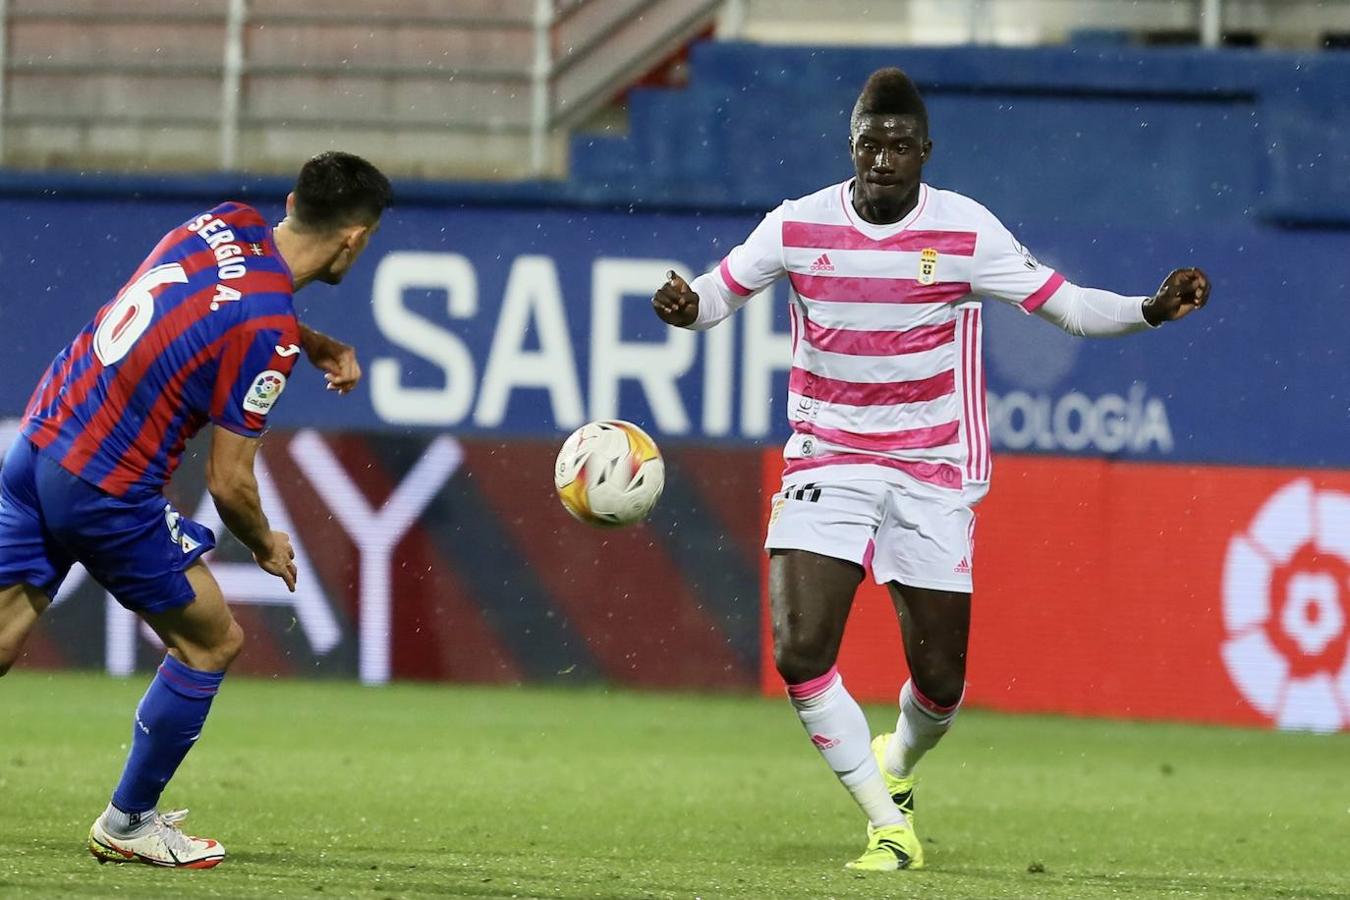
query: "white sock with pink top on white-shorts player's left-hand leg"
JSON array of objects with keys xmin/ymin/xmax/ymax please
[{"xmin": 787, "ymin": 668, "xmax": 905, "ymax": 828}]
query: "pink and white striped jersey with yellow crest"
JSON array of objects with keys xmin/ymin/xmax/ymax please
[{"xmin": 693, "ymin": 179, "xmax": 1072, "ymax": 488}]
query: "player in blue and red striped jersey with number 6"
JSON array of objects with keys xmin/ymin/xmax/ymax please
[{"xmin": 0, "ymin": 152, "xmax": 390, "ymax": 869}]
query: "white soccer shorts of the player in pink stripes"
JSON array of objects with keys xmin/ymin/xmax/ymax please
[{"xmin": 764, "ymin": 474, "xmax": 987, "ymax": 594}]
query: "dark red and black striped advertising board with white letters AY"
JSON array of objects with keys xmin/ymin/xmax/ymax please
[{"xmin": 10, "ymin": 430, "xmax": 761, "ymax": 688}]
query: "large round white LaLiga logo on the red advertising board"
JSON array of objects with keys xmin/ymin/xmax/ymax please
[{"xmin": 1222, "ymin": 479, "xmax": 1350, "ymax": 731}]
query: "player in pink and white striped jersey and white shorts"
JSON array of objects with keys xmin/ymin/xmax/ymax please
[{"xmin": 652, "ymin": 69, "xmax": 1210, "ymax": 870}]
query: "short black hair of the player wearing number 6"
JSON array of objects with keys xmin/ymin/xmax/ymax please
[{"xmin": 288, "ymin": 150, "xmax": 394, "ymax": 231}]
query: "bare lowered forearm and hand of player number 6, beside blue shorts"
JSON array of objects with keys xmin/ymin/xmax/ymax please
[{"xmin": 207, "ymin": 425, "xmax": 297, "ymax": 591}]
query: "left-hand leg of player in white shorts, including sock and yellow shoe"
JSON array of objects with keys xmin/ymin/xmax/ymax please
[{"xmin": 770, "ymin": 551, "xmax": 923, "ymax": 870}]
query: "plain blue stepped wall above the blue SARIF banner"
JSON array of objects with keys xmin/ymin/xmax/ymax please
[{"xmin": 574, "ymin": 43, "xmax": 1350, "ymax": 224}]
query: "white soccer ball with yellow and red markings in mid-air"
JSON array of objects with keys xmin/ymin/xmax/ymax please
[{"xmin": 554, "ymin": 420, "xmax": 666, "ymax": 526}]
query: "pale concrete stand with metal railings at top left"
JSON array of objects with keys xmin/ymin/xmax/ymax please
[{"xmin": 0, "ymin": 0, "xmax": 718, "ymax": 178}]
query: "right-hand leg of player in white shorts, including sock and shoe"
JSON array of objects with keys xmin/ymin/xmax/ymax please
[{"xmin": 873, "ymin": 583, "xmax": 971, "ymax": 823}]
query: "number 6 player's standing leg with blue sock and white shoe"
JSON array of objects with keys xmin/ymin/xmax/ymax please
[{"xmin": 89, "ymin": 561, "xmax": 243, "ymax": 869}]
